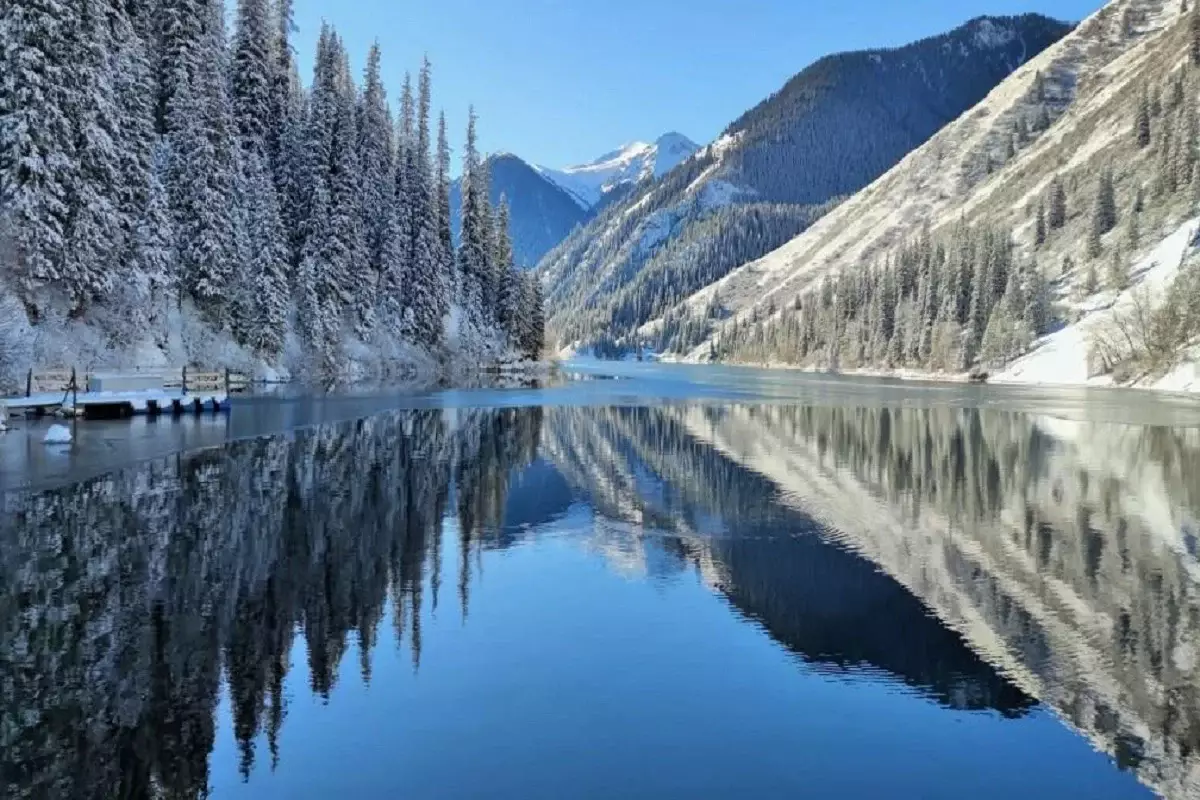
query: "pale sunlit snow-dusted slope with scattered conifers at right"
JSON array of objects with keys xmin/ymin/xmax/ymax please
[{"xmin": 662, "ymin": 0, "xmax": 1200, "ymax": 389}]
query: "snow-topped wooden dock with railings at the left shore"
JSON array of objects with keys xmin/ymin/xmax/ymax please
[{"xmin": 0, "ymin": 367, "xmax": 250, "ymax": 419}]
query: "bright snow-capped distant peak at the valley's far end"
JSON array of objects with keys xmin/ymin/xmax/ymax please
[{"xmin": 536, "ymin": 132, "xmax": 700, "ymax": 210}]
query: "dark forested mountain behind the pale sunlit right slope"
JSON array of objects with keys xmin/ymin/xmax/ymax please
[{"xmin": 540, "ymin": 14, "xmax": 1069, "ymax": 357}]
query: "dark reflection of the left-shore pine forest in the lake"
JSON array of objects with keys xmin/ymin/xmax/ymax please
[{"xmin": 0, "ymin": 410, "xmax": 549, "ymax": 796}]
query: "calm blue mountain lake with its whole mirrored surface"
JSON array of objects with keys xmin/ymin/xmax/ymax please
[{"xmin": 0, "ymin": 365, "xmax": 1200, "ymax": 800}]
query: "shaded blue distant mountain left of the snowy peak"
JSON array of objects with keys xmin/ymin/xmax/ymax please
[{"xmin": 450, "ymin": 152, "xmax": 588, "ymax": 267}]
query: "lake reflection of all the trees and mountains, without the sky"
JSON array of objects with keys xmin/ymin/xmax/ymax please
[{"xmin": 0, "ymin": 405, "xmax": 1200, "ymax": 798}]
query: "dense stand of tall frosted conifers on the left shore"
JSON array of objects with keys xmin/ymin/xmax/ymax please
[{"xmin": 0, "ymin": 0, "xmax": 540, "ymax": 388}]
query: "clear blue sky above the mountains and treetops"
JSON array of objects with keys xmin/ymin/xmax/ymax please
[{"xmin": 288, "ymin": 0, "xmax": 1100, "ymax": 167}]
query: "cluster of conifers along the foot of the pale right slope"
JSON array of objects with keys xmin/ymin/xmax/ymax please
[{"xmin": 710, "ymin": 223, "xmax": 1051, "ymax": 372}]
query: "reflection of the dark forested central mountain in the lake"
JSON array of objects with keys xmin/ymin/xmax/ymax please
[{"xmin": 542, "ymin": 409, "xmax": 1031, "ymax": 715}]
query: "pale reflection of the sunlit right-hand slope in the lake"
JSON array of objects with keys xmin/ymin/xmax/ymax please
[{"xmin": 677, "ymin": 408, "xmax": 1200, "ymax": 798}]
